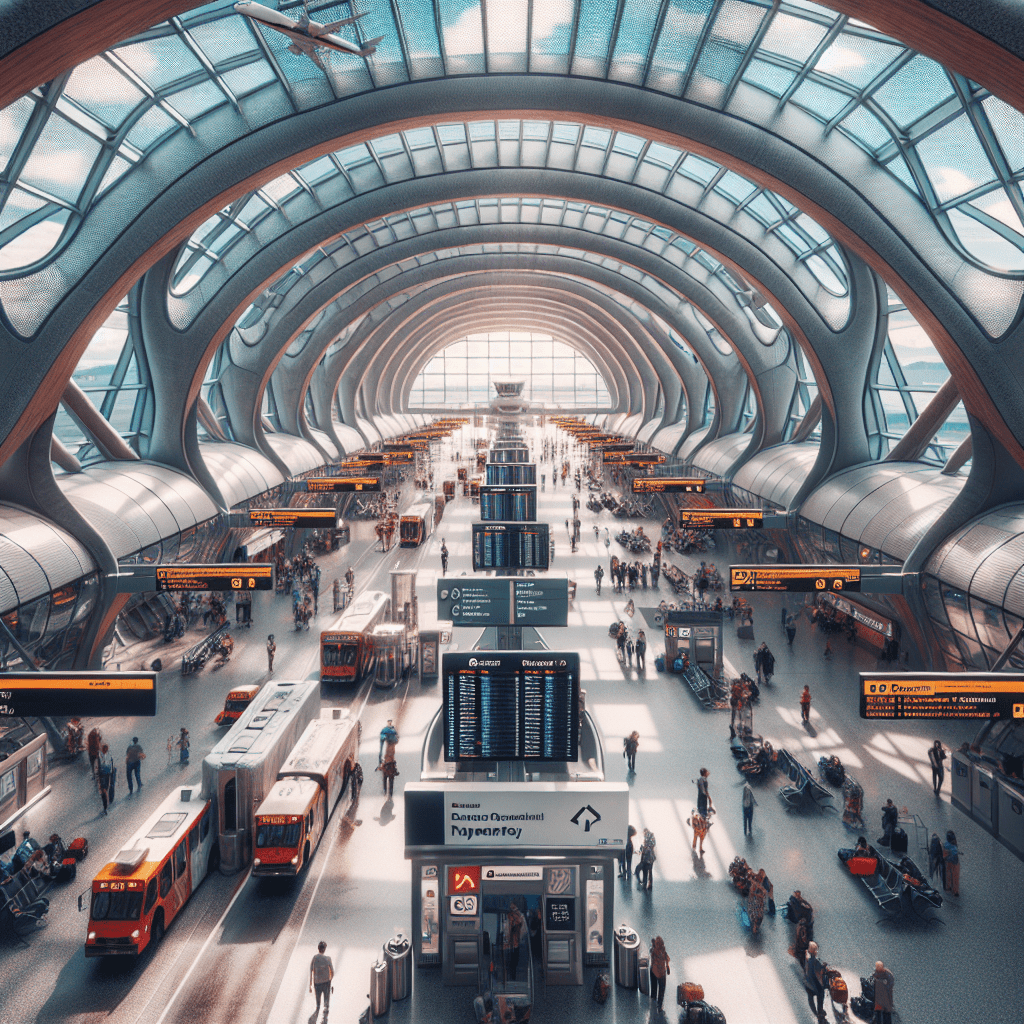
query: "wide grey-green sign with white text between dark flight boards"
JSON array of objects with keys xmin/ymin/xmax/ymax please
[{"xmin": 437, "ymin": 577, "xmax": 569, "ymax": 626}]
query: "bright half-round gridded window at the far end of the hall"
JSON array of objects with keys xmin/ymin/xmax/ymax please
[{"xmin": 410, "ymin": 331, "xmax": 611, "ymax": 410}]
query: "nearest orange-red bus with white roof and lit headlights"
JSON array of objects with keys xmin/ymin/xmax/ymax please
[{"xmin": 85, "ymin": 784, "xmax": 217, "ymax": 956}]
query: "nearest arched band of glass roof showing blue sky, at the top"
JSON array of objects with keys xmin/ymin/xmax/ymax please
[{"xmin": 0, "ymin": 0, "xmax": 1024, "ymax": 284}]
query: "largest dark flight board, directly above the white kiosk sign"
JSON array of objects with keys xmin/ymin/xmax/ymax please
[{"xmin": 441, "ymin": 651, "xmax": 580, "ymax": 761}]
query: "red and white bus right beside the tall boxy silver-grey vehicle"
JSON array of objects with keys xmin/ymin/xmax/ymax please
[{"xmin": 253, "ymin": 708, "xmax": 361, "ymax": 877}]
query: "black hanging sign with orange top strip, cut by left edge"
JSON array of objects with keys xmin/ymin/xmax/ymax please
[{"xmin": 0, "ymin": 672, "xmax": 157, "ymax": 718}]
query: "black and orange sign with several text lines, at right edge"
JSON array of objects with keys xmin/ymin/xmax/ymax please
[{"xmin": 860, "ymin": 672, "xmax": 1024, "ymax": 722}]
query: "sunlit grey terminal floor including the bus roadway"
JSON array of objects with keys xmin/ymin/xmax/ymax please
[{"xmin": 0, "ymin": 432, "xmax": 1024, "ymax": 1024}]
